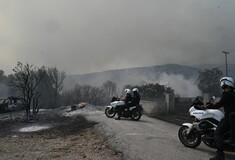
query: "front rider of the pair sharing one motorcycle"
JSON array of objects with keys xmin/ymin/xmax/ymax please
[{"xmin": 116, "ymin": 89, "xmax": 132, "ymax": 120}]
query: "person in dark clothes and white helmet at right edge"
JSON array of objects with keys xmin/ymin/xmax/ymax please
[{"xmin": 206, "ymin": 77, "xmax": 235, "ymax": 160}]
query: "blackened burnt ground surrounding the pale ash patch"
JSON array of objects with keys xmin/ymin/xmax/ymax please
[{"xmin": 0, "ymin": 113, "xmax": 97, "ymax": 138}]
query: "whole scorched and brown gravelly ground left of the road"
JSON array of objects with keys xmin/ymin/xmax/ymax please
[{"xmin": 0, "ymin": 109, "xmax": 123, "ymax": 160}]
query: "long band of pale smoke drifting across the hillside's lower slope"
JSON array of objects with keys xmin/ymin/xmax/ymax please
[{"xmin": 65, "ymin": 66, "xmax": 202, "ymax": 97}]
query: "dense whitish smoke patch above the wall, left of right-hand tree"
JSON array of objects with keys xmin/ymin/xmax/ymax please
[{"xmin": 158, "ymin": 73, "xmax": 202, "ymax": 97}]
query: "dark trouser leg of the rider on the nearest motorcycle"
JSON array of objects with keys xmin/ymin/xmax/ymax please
[{"xmin": 215, "ymin": 118, "xmax": 230, "ymax": 152}]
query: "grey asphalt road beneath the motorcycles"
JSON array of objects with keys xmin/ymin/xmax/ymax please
[{"xmin": 75, "ymin": 106, "xmax": 235, "ymax": 160}]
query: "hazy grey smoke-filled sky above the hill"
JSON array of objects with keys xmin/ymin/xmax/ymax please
[{"xmin": 0, "ymin": 0, "xmax": 235, "ymax": 74}]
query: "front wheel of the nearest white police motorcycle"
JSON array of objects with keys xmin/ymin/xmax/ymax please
[{"xmin": 178, "ymin": 126, "xmax": 201, "ymax": 148}]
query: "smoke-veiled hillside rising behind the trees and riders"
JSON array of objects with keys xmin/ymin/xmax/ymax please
[{"xmin": 65, "ymin": 64, "xmax": 202, "ymax": 96}]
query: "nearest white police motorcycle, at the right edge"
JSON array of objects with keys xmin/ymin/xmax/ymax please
[{"xmin": 178, "ymin": 97, "xmax": 235, "ymax": 152}]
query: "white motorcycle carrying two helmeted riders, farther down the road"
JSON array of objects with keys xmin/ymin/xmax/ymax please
[{"xmin": 105, "ymin": 97, "xmax": 143, "ymax": 121}]
